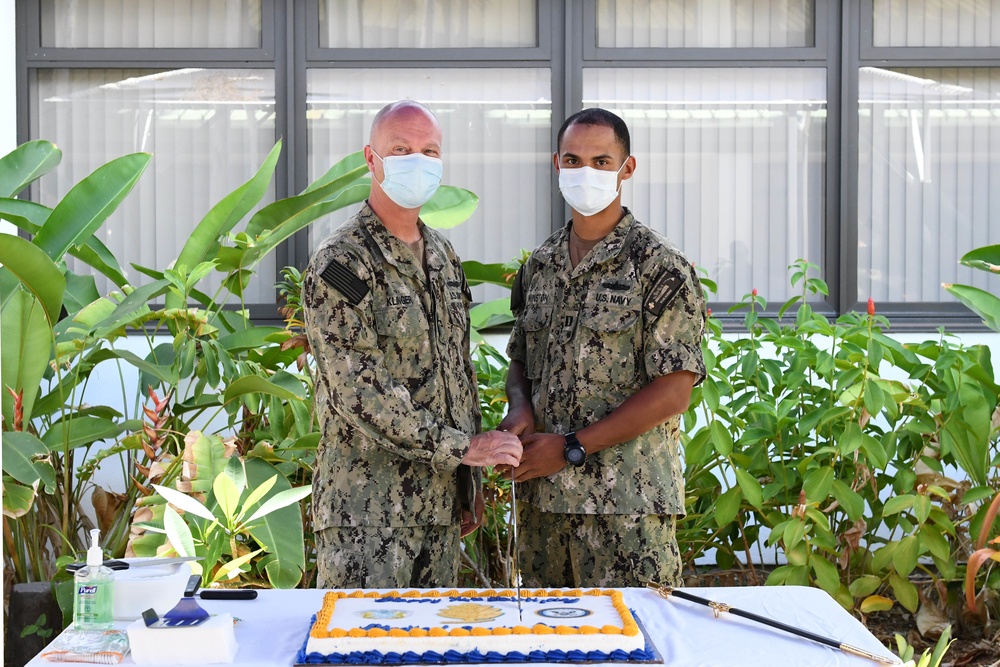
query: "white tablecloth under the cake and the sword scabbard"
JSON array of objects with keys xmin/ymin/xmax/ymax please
[{"xmin": 28, "ymin": 586, "xmax": 892, "ymax": 667}]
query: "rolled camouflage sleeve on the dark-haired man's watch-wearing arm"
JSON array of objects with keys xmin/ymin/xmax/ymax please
[{"xmin": 643, "ymin": 262, "xmax": 706, "ymax": 384}]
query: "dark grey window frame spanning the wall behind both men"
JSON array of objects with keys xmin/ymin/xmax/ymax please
[{"xmin": 15, "ymin": 0, "xmax": 1000, "ymax": 331}]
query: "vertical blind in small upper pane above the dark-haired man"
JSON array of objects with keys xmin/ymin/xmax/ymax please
[{"xmin": 597, "ymin": 0, "xmax": 816, "ymax": 48}]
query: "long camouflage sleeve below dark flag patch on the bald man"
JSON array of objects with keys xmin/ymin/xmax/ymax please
[{"xmin": 302, "ymin": 257, "xmax": 470, "ymax": 472}]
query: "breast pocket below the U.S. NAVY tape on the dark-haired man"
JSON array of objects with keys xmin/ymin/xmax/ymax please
[{"xmin": 577, "ymin": 305, "xmax": 640, "ymax": 386}]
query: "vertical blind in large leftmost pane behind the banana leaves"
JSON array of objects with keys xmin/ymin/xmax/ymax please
[{"xmin": 31, "ymin": 68, "xmax": 275, "ymax": 303}]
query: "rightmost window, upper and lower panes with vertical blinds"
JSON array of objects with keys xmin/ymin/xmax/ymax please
[{"xmin": 856, "ymin": 0, "xmax": 1000, "ymax": 319}]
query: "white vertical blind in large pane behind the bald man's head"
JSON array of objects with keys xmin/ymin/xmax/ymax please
[{"xmin": 307, "ymin": 68, "xmax": 552, "ymax": 298}]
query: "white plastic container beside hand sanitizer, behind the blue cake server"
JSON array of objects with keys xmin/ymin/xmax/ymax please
[{"xmin": 112, "ymin": 558, "xmax": 191, "ymax": 621}]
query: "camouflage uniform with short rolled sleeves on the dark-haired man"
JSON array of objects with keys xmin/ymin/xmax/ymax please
[{"xmin": 507, "ymin": 209, "xmax": 705, "ymax": 586}]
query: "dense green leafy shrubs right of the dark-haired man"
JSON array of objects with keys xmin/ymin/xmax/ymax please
[{"xmin": 678, "ymin": 262, "xmax": 1000, "ymax": 632}]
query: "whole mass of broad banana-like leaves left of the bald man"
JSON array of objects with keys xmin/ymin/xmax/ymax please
[{"xmin": 0, "ymin": 141, "xmax": 478, "ymax": 585}]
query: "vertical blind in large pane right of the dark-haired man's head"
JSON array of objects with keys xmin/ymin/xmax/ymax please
[{"xmin": 583, "ymin": 68, "xmax": 826, "ymax": 301}]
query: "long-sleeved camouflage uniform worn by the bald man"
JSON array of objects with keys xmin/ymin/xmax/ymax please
[{"xmin": 303, "ymin": 203, "xmax": 480, "ymax": 588}]
